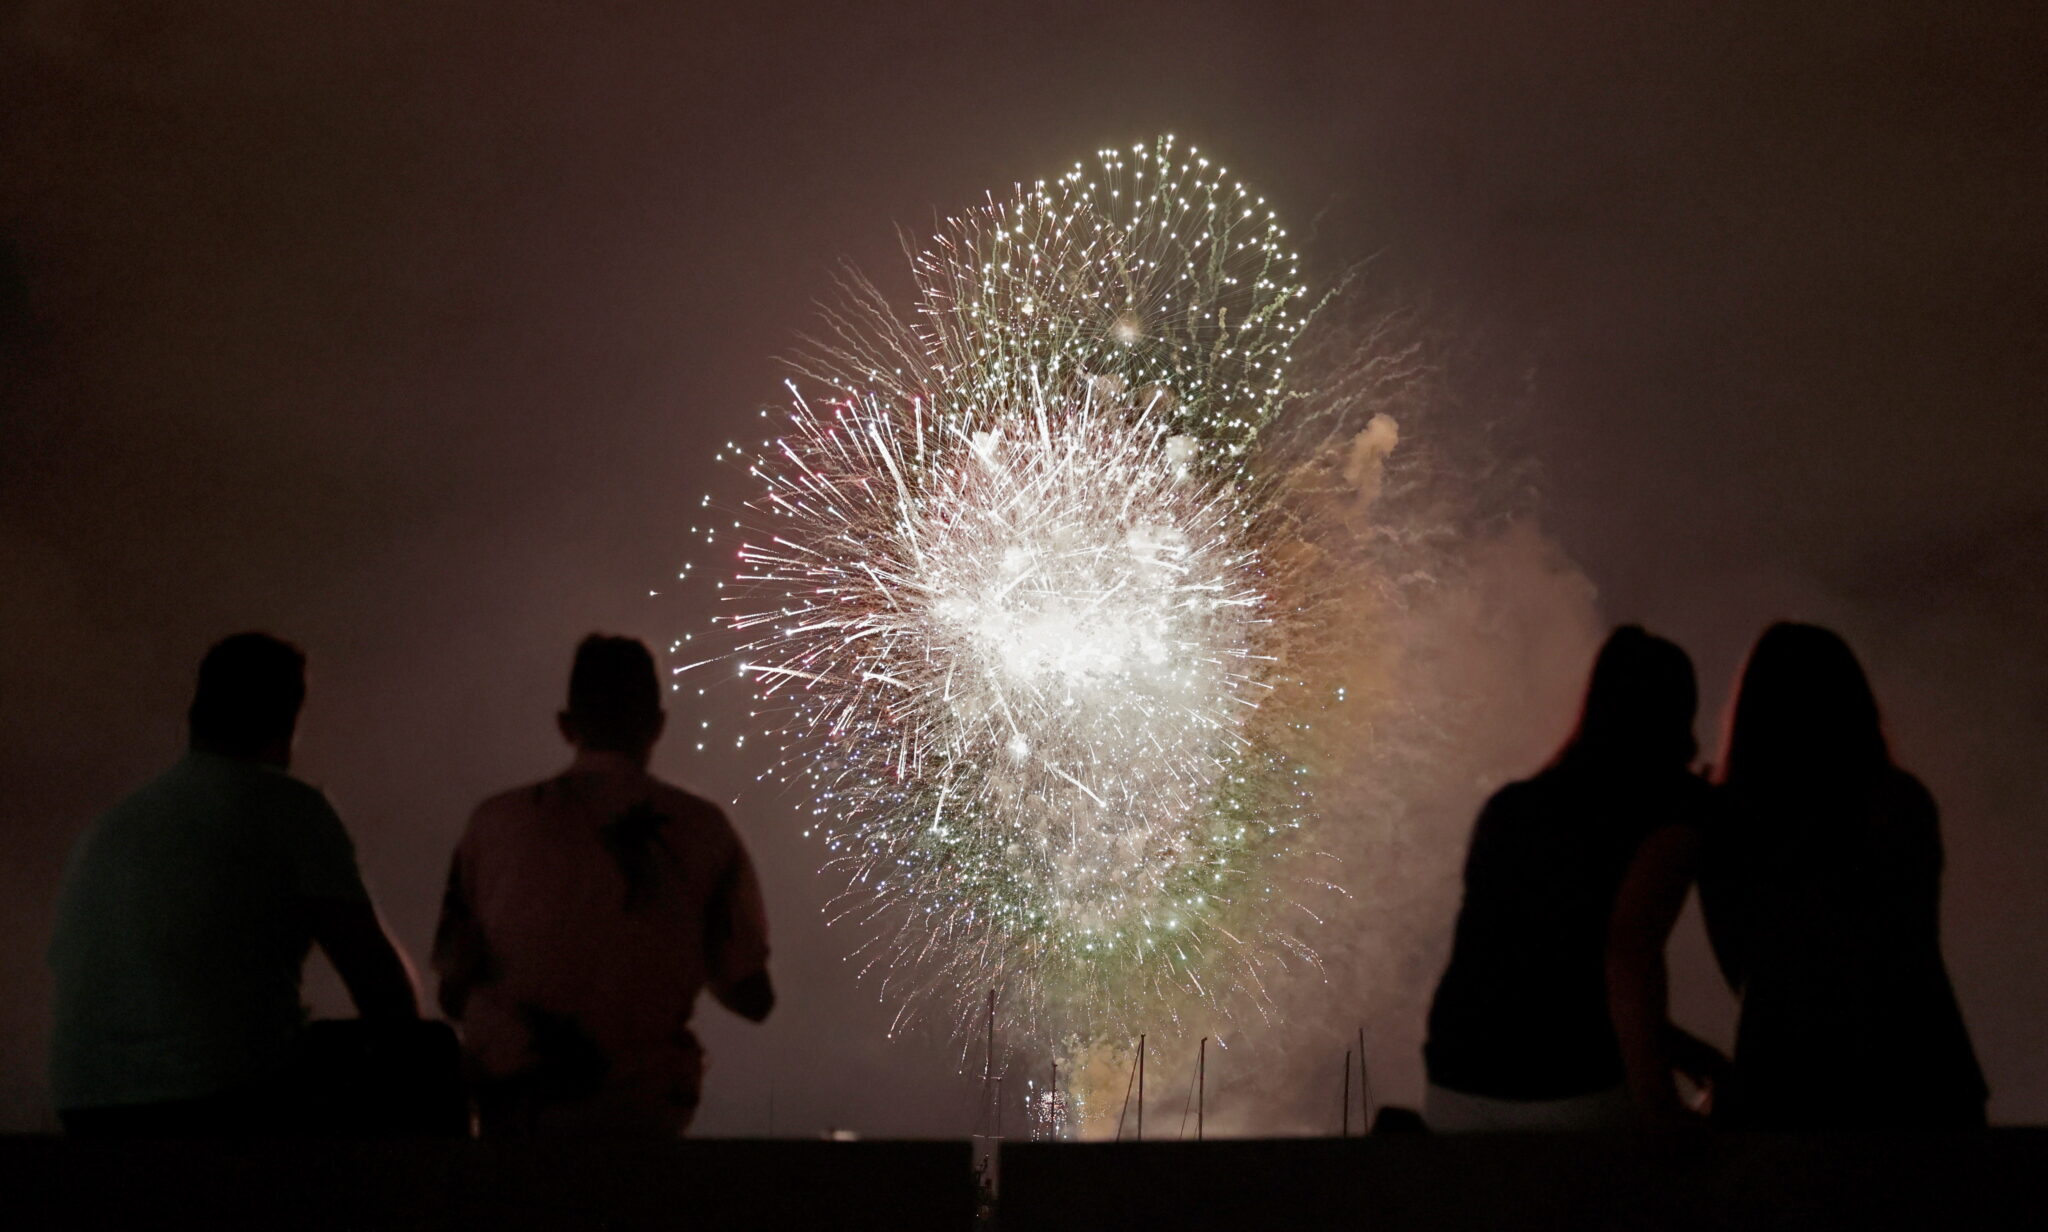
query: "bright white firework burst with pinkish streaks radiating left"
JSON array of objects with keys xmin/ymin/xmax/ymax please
[{"xmin": 741, "ymin": 385, "xmax": 1262, "ymax": 948}]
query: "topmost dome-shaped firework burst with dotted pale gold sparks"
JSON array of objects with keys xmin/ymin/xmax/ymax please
[{"xmin": 799, "ymin": 137, "xmax": 1309, "ymax": 463}]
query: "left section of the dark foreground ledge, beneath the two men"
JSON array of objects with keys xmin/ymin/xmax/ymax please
[{"xmin": 0, "ymin": 1136, "xmax": 975, "ymax": 1232}]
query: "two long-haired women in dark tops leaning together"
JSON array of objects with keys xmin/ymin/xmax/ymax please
[{"xmin": 1423, "ymin": 624, "xmax": 1987, "ymax": 1130}]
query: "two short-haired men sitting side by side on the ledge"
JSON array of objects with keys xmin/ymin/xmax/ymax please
[{"xmin": 49, "ymin": 634, "xmax": 774, "ymax": 1136}]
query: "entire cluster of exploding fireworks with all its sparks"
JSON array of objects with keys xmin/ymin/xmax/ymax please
[{"xmin": 678, "ymin": 139, "xmax": 1395, "ymax": 1046}]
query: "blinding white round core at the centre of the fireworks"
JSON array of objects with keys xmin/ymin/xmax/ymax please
[{"xmin": 905, "ymin": 407, "xmax": 1260, "ymax": 829}]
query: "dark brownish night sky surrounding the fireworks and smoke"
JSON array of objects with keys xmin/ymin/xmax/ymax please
[{"xmin": 0, "ymin": 0, "xmax": 2048, "ymax": 1134}]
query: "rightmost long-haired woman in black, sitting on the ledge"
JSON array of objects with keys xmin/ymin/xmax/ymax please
[{"xmin": 1700, "ymin": 624, "xmax": 1987, "ymax": 1130}]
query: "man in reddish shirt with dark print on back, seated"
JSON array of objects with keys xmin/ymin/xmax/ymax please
[{"xmin": 434, "ymin": 634, "xmax": 774, "ymax": 1138}]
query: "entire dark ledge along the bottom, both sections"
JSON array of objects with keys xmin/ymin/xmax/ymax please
[{"xmin": 0, "ymin": 1130, "xmax": 2048, "ymax": 1232}]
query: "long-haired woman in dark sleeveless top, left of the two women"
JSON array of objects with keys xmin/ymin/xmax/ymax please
[{"xmin": 1423, "ymin": 626, "xmax": 1712, "ymax": 1130}]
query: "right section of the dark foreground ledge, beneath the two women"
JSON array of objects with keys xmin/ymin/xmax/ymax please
[{"xmin": 1001, "ymin": 1130, "xmax": 2048, "ymax": 1232}]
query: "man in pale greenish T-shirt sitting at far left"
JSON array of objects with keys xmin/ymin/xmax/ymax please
[{"xmin": 49, "ymin": 632, "xmax": 418, "ymax": 1136}]
